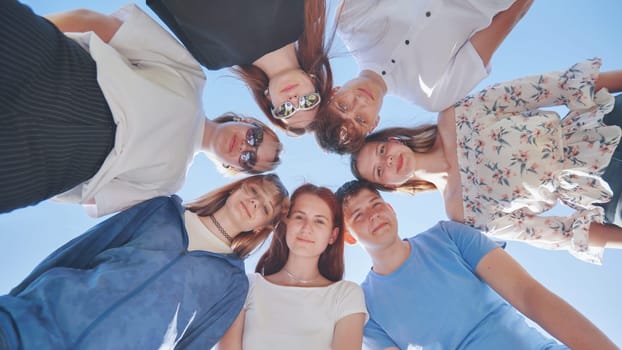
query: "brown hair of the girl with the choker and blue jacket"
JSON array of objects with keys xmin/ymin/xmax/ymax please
[{"xmin": 185, "ymin": 174, "xmax": 289, "ymax": 258}]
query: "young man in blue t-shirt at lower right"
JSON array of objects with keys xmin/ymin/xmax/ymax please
[{"xmin": 337, "ymin": 181, "xmax": 617, "ymax": 350}]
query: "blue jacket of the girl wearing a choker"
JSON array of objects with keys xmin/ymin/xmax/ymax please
[{"xmin": 0, "ymin": 196, "xmax": 248, "ymax": 350}]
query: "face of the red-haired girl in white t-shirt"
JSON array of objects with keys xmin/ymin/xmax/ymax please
[{"xmin": 285, "ymin": 193, "xmax": 339, "ymax": 257}]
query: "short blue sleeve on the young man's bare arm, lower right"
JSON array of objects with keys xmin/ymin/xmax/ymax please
[{"xmin": 440, "ymin": 221, "xmax": 505, "ymax": 271}]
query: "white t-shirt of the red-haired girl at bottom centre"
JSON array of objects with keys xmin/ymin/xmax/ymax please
[{"xmin": 243, "ymin": 273, "xmax": 367, "ymax": 350}]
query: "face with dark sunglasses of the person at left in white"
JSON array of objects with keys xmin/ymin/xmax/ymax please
[{"xmin": 213, "ymin": 122, "xmax": 279, "ymax": 172}]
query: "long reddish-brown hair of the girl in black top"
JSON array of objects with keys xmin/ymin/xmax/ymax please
[{"xmin": 232, "ymin": 0, "xmax": 335, "ymax": 135}]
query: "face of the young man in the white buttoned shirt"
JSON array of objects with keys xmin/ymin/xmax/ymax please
[{"xmin": 328, "ymin": 77, "xmax": 384, "ymax": 135}]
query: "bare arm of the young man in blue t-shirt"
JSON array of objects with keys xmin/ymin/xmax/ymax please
[{"xmin": 475, "ymin": 248, "xmax": 617, "ymax": 349}]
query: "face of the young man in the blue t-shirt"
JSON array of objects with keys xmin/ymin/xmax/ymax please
[{"xmin": 343, "ymin": 189, "xmax": 399, "ymax": 250}]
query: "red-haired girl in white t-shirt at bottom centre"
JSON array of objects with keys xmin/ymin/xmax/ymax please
[{"xmin": 218, "ymin": 184, "xmax": 367, "ymax": 350}]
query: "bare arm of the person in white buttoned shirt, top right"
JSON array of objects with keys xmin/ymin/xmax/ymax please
[{"xmin": 471, "ymin": 0, "xmax": 533, "ymax": 66}]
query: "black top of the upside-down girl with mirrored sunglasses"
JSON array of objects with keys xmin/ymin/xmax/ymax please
[{"xmin": 147, "ymin": 0, "xmax": 304, "ymax": 69}]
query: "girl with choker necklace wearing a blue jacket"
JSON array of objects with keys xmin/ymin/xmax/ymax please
[{"xmin": 0, "ymin": 174, "xmax": 289, "ymax": 349}]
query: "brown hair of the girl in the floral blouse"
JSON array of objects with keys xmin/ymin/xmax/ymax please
[{"xmin": 350, "ymin": 124, "xmax": 437, "ymax": 195}]
